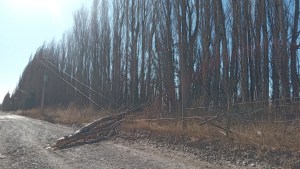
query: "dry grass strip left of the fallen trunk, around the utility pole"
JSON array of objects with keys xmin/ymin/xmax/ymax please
[{"xmin": 19, "ymin": 104, "xmax": 109, "ymax": 124}]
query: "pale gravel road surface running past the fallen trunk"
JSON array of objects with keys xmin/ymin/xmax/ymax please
[{"xmin": 0, "ymin": 112, "xmax": 258, "ymax": 169}]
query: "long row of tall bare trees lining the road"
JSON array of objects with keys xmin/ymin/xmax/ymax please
[{"xmin": 4, "ymin": 0, "xmax": 299, "ymax": 115}]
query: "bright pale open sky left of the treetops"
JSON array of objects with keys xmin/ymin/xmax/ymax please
[{"xmin": 0, "ymin": 0, "xmax": 92, "ymax": 103}]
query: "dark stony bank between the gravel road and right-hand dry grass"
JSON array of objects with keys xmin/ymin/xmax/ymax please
[{"xmin": 117, "ymin": 129, "xmax": 300, "ymax": 169}]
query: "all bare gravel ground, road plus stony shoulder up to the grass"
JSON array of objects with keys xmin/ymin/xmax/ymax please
[{"xmin": 0, "ymin": 112, "xmax": 300, "ymax": 169}]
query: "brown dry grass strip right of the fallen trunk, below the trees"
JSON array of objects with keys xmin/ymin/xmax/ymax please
[{"xmin": 123, "ymin": 119, "xmax": 300, "ymax": 153}]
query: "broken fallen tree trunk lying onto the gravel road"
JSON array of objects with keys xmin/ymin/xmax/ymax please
[{"xmin": 53, "ymin": 113, "xmax": 127, "ymax": 149}]
